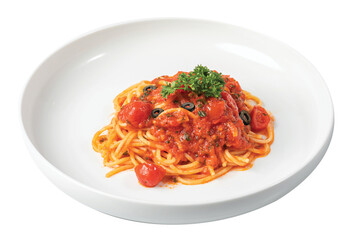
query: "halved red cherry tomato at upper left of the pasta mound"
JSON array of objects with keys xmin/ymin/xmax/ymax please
[{"xmin": 118, "ymin": 101, "xmax": 152, "ymax": 128}]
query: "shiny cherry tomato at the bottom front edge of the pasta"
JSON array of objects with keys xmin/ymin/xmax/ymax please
[{"xmin": 135, "ymin": 163, "xmax": 166, "ymax": 187}]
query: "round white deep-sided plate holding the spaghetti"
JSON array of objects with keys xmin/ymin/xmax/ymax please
[{"xmin": 21, "ymin": 19, "xmax": 333, "ymax": 223}]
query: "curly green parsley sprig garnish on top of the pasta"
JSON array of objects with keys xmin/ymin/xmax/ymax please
[{"xmin": 161, "ymin": 65, "xmax": 225, "ymax": 98}]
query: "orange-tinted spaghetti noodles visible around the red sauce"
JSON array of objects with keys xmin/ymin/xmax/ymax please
[{"xmin": 92, "ymin": 67, "xmax": 274, "ymax": 185}]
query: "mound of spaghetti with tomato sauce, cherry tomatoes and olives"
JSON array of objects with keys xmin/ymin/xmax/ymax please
[{"xmin": 92, "ymin": 66, "xmax": 274, "ymax": 186}]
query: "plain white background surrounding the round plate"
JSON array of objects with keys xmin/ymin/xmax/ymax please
[{"xmin": 0, "ymin": 0, "xmax": 350, "ymax": 239}]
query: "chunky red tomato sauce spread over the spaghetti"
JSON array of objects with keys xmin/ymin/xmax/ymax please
[{"xmin": 119, "ymin": 72, "xmax": 252, "ymax": 168}]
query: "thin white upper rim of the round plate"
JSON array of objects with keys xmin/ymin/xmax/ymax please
[{"xmin": 19, "ymin": 17, "xmax": 334, "ymax": 206}]
